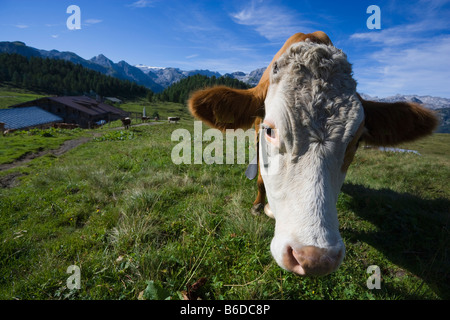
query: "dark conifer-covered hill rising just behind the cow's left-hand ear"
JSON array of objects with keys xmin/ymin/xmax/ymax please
[{"xmin": 156, "ymin": 74, "xmax": 250, "ymax": 103}]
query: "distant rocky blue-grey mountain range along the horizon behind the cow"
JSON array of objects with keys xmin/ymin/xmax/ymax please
[{"xmin": 0, "ymin": 41, "xmax": 450, "ymax": 110}]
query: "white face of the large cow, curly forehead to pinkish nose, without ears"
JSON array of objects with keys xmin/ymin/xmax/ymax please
[{"xmin": 259, "ymin": 41, "xmax": 364, "ymax": 275}]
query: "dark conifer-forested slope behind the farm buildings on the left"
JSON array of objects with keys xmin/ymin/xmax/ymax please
[{"xmin": 0, "ymin": 54, "xmax": 150, "ymax": 98}]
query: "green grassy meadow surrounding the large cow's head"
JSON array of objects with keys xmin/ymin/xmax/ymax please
[{"xmin": 0, "ymin": 93, "xmax": 450, "ymax": 300}]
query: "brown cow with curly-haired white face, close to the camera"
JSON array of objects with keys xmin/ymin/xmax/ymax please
[{"xmin": 189, "ymin": 31, "xmax": 438, "ymax": 276}]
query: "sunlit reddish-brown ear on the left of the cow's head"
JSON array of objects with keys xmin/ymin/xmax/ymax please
[{"xmin": 189, "ymin": 86, "xmax": 264, "ymax": 130}]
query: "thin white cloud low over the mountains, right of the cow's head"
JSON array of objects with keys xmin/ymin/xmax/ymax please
[{"xmin": 353, "ymin": 36, "xmax": 450, "ymax": 97}]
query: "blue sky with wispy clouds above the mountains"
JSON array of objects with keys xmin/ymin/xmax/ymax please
[{"xmin": 0, "ymin": 0, "xmax": 450, "ymax": 98}]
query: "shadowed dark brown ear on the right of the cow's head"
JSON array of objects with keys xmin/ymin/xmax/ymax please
[{"xmin": 359, "ymin": 97, "xmax": 439, "ymax": 146}]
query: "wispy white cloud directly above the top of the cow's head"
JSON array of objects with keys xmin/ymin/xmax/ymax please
[{"xmin": 231, "ymin": 1, "xmax": 310, "ymax": 41}]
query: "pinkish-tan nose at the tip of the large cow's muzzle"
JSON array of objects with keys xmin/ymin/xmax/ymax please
[{"xmin": 283, "ymin": 246, "xmax": 343, "ymax": 276}]
